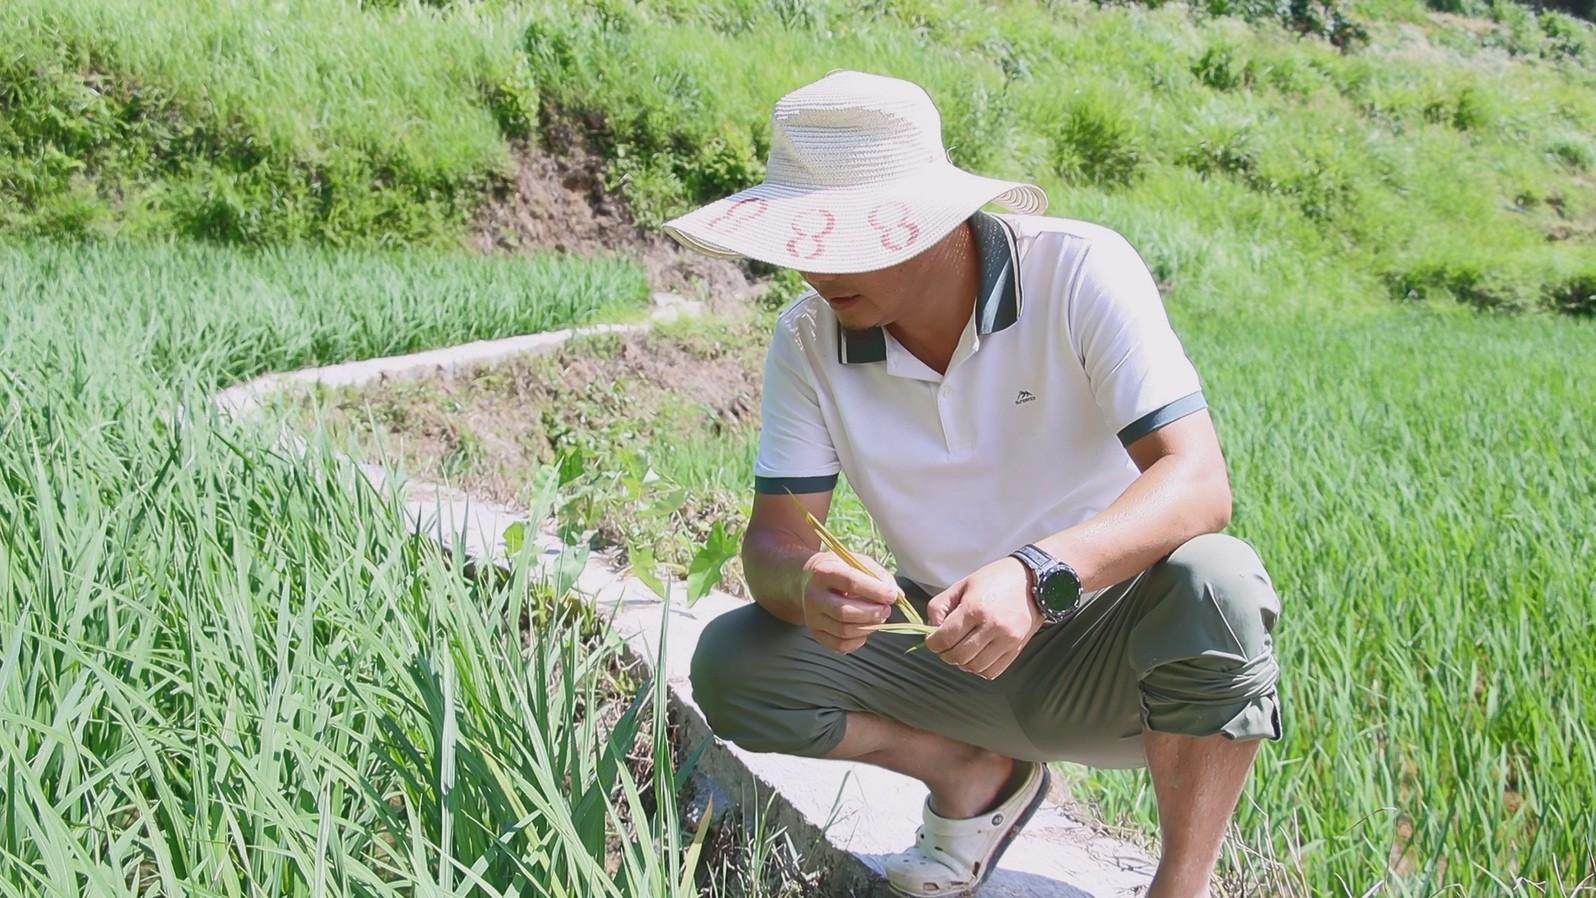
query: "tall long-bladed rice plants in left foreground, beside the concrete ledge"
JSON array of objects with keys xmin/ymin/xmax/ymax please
[{"xmin": 0, "ymin": 386, "xmax": 718, "ymax": 896}]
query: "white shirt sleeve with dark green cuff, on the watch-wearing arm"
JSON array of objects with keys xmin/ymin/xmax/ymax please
[{"xmin": 1068, "ymin": 234, "xmax": 1207, "ymax": 445}]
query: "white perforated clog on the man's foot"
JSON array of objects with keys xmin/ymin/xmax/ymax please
[{"xmin": 886, "ymin": 764, "xmax": 1052, "ymax": 898}]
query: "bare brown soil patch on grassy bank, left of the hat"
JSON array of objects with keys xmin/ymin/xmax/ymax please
[{"xmin": 471, "ymin": 124, "xmax": 764, "ymax": 309}]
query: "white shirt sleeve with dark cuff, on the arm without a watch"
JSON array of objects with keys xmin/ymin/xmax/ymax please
[{"xmin": 753, "ymin": 317, "xmax": 841, "ymax": 493}]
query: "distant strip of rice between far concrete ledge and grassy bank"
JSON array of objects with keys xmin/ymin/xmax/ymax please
[{"xmin": 0, "ymin": 242, "xmax": 648, "ymax": 386}]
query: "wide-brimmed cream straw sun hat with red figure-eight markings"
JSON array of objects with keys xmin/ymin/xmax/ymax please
[{"xmin": 664, "ymin": 70, "xmax": 1047, "ymax": 274}]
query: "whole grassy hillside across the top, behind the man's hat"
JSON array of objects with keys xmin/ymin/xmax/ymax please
[{"xmin": 0, "ymin": 0, "xmax": 1596, "ymax": 311}]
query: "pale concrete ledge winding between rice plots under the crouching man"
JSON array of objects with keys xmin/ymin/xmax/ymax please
[{"xmin": 215, "ymin": 312, "xmax": 1154, "ymax": 898}]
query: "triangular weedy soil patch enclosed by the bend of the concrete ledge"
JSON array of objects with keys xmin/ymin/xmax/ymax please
[{"xmin": 286, "ymin": 313, "xmax": 769, "ymax": 580}]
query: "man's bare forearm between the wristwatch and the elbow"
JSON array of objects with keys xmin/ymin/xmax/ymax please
[{"xmin": 1037, "ymin": 455, "xmax": 1231, "ymax": 590}]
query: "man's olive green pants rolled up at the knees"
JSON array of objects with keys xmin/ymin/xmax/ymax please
[{"xmin": 693, "ymin": 534, "xmax": 1280, "ymax": 767}]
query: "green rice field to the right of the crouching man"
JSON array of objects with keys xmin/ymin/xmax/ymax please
[{"xmin": 1076, "ymin": 311, "xmax": 1596, "ymax": 898}]
